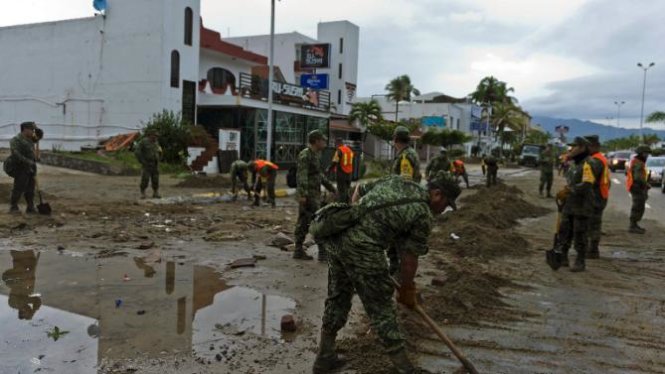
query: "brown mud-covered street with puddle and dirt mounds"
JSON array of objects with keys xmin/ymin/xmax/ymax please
[{"xmin": 0, "ymin": 171, "xmax": 665, "ymax": 373}]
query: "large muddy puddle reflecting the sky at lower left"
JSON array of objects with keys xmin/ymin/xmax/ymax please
[{"xmin": 0, "ymin": 250, "xmax": 296, "ymax": 373}]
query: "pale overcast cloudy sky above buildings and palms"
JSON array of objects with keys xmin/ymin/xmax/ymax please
[{"xmin": 0, "ymin": 0, "xmax": 665, "ymax": 128}]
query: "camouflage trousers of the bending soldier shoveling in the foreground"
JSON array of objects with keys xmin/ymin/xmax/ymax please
[{"xmin": 322, "ymin": 238, "xmax": 404, "ymax": 353}]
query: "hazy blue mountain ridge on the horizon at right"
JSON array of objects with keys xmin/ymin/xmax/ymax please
[{"xmin": 531, "ymin": 116, "xmax": 665, "ymax": 142}]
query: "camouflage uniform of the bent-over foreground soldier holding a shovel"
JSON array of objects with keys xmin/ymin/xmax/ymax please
[{"xmin": 322, "ymin": 176, "xmax": 433, "ymax": 353}]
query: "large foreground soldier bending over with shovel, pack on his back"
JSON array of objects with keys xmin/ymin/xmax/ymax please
[{"xmin": 313, "ymin": 171, "xmax": 460, "ymax": 374}]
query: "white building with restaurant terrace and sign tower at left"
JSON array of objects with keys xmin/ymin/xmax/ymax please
[{"xmin": 0, "ymin": 0, "xmax": 358, "ymax": 166}]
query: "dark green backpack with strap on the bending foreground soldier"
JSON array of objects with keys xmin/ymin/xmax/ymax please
[{"xmin": 309, "ymin": 198, "xmax": 426, "ymax": 242}]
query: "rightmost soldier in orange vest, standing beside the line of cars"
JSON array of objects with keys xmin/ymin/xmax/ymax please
[{"xmin": 626, "ymin": 145, "xmax": 651, "ymax": 234}]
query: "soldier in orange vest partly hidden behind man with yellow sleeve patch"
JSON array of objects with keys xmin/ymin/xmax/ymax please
[{"xmin": 585, "ymin": 135, "xmax": 612, "ymax": 259}]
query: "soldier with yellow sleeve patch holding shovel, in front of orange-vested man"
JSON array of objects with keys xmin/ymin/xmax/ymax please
[{"xmin": 556, "ymin": 137, "xmax": 596, "ymax": 272}]
